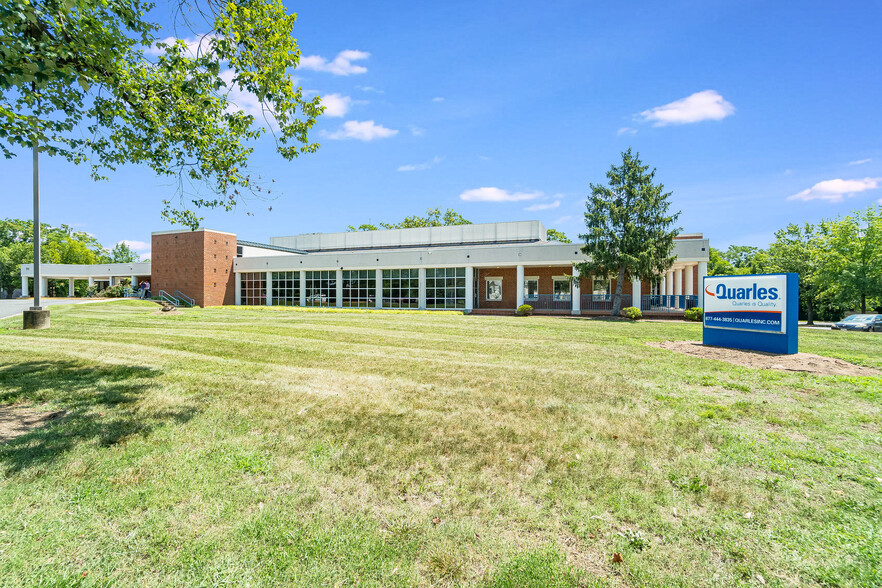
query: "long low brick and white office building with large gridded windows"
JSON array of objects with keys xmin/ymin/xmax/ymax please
[{"xmin": 21, "ymin": 221, "xmax": 710, "ymax": 315}]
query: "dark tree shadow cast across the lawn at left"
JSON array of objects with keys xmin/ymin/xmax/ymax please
[{"xmin": 0, "ymin": 361, "xmax": 196, "ymax": 473}]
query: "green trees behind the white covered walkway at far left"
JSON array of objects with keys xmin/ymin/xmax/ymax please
[{"xmin": 0, "ymin": 218, "xmax": 141, "ymax": 298}]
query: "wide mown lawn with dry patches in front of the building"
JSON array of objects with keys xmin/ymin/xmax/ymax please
[{"xmin": 0, "ymin": 301, "xmax": 882, "ymax": 587}]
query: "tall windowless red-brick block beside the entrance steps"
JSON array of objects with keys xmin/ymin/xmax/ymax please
[{"xmin": 150, "ymin": 230, "xmax": 236, "ymax": 307}]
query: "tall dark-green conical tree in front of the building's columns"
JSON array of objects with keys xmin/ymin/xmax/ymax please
[{"xmin": 576, "ymin": 149, "xmax": 680, "ymax": 316}]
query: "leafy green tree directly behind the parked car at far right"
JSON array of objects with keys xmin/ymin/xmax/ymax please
[{"xmin": 819, "ymin": 206, "xmax": 882, "ymax": 313}]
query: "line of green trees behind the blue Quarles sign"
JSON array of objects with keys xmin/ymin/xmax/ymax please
[{"xmin": 707, "ymin": 206, "xmax": 882, "ymax": 323}]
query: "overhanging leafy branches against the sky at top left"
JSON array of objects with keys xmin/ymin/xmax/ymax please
[{"xmin": 0, "ymin": 0, "xmax": 323, "ymax": 228}]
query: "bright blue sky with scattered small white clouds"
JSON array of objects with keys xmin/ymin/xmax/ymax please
[{"xmin": 0, "ymin": 0, "xmax": 882, "ymax": 258}]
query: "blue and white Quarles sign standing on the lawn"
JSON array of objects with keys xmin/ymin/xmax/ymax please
[{"xmin": 702, "ymin": 274, "xmax": 799, "ymax": 353}]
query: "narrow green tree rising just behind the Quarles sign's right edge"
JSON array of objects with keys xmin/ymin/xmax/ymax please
[{"xmin": 769, "ymin": 223, "xmax": 824, "ymax": 325}]
